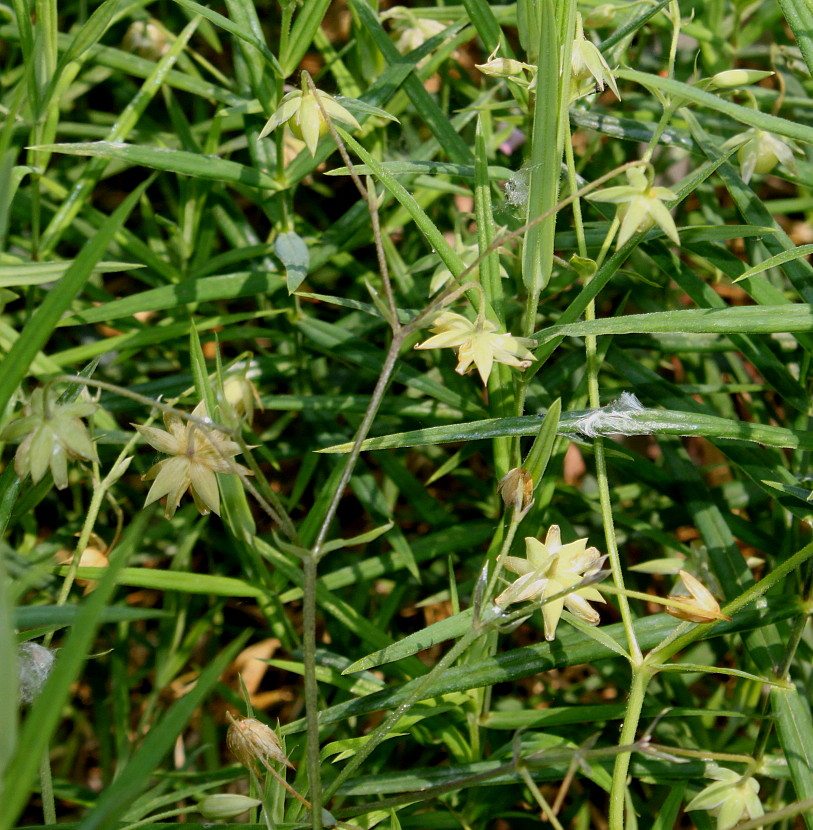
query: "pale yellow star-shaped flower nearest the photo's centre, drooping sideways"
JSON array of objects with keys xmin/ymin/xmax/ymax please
[{"xmin": 415, "ymin": 311, "xmax": 536, "ymax": 384}]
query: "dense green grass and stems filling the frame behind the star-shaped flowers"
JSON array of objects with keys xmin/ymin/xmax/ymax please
[{"xmin": 0, "ymin": 0, "xmax": 813, "ymax": 830}]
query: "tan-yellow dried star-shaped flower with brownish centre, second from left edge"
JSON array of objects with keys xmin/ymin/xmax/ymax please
[{"xmin": 133, "ymin": 409, "xmax": 250, "ymax": 519}]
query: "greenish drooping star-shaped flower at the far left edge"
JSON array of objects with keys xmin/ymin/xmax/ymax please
[{"xmin": 0, "ymin": 387, "xmax": 99, "ymax": 490}]
